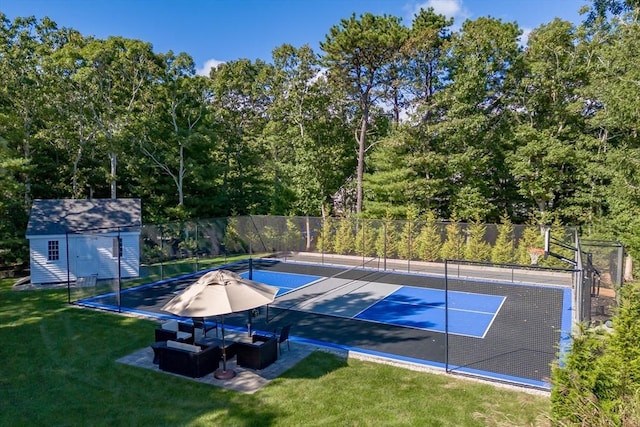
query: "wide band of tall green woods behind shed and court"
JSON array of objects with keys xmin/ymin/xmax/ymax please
[{"xmin": 0, "ymin": 0, "xmax": 640, "ymax": 268}]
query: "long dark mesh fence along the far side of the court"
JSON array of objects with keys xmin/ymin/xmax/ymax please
[{"xmin": 141, "ymin": 216, "xmax": 575, "ymax": 274}]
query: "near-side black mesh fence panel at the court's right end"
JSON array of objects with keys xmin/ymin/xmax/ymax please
[{"xmin": 445, "ymin": 260, "xmax": 581, "ymax": 388}]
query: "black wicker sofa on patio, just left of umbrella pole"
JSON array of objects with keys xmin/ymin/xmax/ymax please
[{"xmin": 155, "ymin": 340, "xmax": 222, "ymax": 378}]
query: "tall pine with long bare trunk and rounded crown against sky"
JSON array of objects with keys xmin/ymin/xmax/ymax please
[{"xmin": 320, "ymin": 13, "xmax": 406, "ymax": 213}]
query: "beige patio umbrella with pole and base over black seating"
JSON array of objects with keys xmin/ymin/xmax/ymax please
[{"xmin": 162, "ymin": 270, "xmax": 278, "ymax": 379}]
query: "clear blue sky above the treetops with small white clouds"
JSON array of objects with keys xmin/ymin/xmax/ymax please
[{"xmin": 0, "ymin": 0, "xmax": 591, "ymax": 74}]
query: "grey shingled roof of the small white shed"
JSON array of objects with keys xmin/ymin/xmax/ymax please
[{"xmin": 26, "ymin": 199, "xmax": 142, "ymax": 237}]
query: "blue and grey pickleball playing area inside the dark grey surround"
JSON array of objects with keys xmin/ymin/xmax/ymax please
[{"xmin": 242, "ymin": 270, "xmax": 505, "ymax": 338}]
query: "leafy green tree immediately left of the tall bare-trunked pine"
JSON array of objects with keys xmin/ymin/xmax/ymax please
[{"xmin": 263, "ymin": 44, "xmax": 353, "ymax": 215}]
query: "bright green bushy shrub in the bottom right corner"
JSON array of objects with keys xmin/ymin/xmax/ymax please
[{"xmin": 551, "ymin": 283, "xmax": 640, "ymax": 426}]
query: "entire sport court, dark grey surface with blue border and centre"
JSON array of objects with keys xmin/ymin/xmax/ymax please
[{"xmin": 79, "ymin": 260, "xmax": 572, "ymax": 388}]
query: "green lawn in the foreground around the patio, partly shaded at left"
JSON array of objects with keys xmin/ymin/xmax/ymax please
[{"xmin": 0, "ymin": 280, "xmax": 549, "ymax": 426}]
